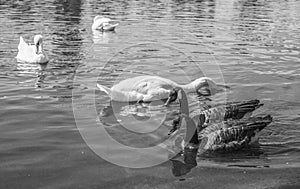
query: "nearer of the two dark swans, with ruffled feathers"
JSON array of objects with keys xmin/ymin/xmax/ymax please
[{"xmin": 171, "ymin": 88, "xmax": 272, "ymax": 152}]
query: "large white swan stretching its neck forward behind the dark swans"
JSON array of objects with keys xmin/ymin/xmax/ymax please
[{"xmin": 97, "ymin": 75, "xmax": 227, "ymax": 105}]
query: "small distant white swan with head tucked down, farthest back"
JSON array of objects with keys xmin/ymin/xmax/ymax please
[{"xmin": 92, "ymin": 15, "xmax": 119, "ymax": 31}]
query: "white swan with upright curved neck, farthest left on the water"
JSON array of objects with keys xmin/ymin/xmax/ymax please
[{"xmin": 16, "ymin": 35, "xmax": 49, "ymax": 64}]
